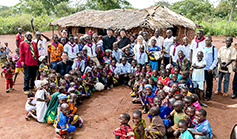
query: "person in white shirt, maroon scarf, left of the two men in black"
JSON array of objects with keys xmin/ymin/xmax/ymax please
[{"xmin": 84, "ymin": 36, "xmax": 100, "ymax": 66}]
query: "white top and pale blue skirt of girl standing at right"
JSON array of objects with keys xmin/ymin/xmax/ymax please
[{"xmin": 192, "ymin": 58, "xmax": 206, "ymax": 82}]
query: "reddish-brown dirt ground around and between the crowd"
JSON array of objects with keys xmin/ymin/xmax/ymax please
[{"xmin": 0, "ymin": 32, "xmax": 237, "ymax": 139}]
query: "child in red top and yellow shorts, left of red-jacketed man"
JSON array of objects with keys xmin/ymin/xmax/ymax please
[{"xmin": 13, "ymin": 48, "xmax": 24, "ymax": 83}]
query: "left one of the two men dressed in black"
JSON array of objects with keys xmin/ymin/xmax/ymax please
[{"xmin": 102, "ymin": 28, "xmax": 117, "ymax": 50}]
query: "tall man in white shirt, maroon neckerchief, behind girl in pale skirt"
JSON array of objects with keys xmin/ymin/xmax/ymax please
[{"xmin": 190, "ymin": 30, "xmax": 206, "ymax": 63}]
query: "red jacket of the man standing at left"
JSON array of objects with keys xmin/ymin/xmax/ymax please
[{"xmin": 19, "ymin": 41, "xmax": 39, "ymax": 66}]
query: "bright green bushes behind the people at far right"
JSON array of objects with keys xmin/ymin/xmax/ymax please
[{"xmin": 200, "ymin": 20, "xmax": 237, "ymax": 37}]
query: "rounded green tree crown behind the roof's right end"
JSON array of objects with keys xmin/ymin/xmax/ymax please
[{"xmin": 172, "ymin": 0, "xmax": 214, "ymax": 21}]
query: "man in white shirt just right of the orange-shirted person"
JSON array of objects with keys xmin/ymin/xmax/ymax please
[{"xmin": 63, "ymin": 34, "xmax": 79, "ymax": 61}]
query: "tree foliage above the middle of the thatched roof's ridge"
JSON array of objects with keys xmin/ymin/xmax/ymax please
[{"xmin": 85, "ymin": 0, "xmax": 131, "ymax": 10}]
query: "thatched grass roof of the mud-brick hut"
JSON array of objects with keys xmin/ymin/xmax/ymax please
[{"xmin": 49, "ymin": 5, "xmax": 195, "ymax": 30}]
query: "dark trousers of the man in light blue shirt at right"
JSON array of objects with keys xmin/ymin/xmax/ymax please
[{"xmin": 205, "ymin": 70, "xmax": 213, "ymax": 99}]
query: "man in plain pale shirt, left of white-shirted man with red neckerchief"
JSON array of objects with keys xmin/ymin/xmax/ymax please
[{"xmin": 162, "ymin": 29, "xmax": 174, "ymax": 65}]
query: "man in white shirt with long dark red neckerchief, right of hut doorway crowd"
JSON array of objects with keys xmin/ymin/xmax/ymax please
[{"xmin": 170, "ymin": 36, "xmax": 184, "ymax": 66}]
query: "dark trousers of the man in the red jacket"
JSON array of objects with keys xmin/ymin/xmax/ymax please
[{"xmin": 23, "ymin": 65, "xmax": 37, "ymax": 91}]
